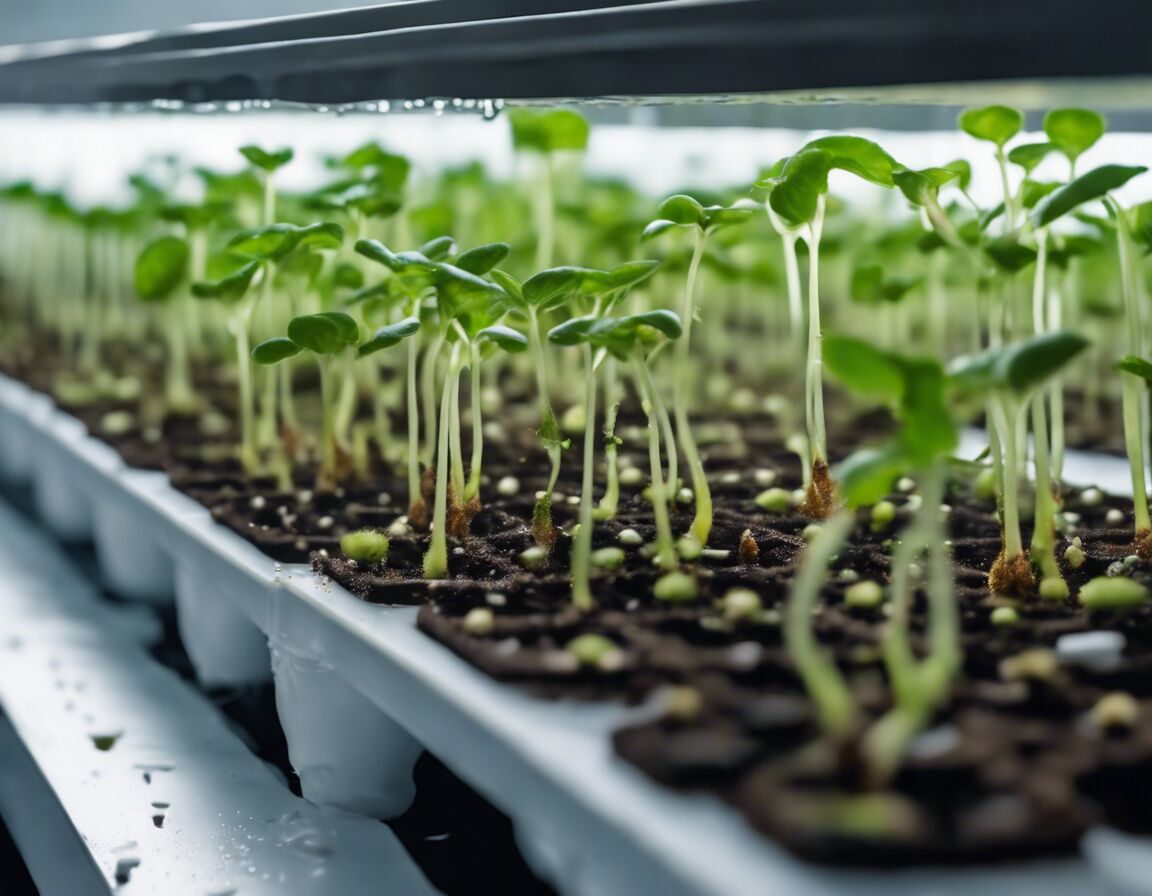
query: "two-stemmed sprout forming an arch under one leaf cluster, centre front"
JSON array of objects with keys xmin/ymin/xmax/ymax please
[{"xmin": 548, "ymin": 306, "xmax": 683, "ymax": 609}]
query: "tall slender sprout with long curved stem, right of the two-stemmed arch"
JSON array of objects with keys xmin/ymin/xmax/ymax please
[{"xmin": 642, "ymin": 195, "xmax": 755, "ymax": 545}]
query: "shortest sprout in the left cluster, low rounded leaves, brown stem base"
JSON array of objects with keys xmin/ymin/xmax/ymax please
[{"xmin": 252, "ymin": 311, "xmax": 359, "ymax": 491}]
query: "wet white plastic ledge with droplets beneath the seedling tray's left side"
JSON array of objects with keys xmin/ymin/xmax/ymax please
[{"xmin": 0, "ymin": 501, "xmax": 434, "ymax": 896}]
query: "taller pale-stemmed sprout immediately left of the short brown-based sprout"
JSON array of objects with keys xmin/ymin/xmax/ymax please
[{"xmin": 192, "ymin": 222, "xmax": 343, "ymax": 474}]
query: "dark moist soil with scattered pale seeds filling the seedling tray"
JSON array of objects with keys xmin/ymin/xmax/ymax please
[{"xmin": 6, "ymin": 345, "xmax": 1152, "ymax": 866}]
